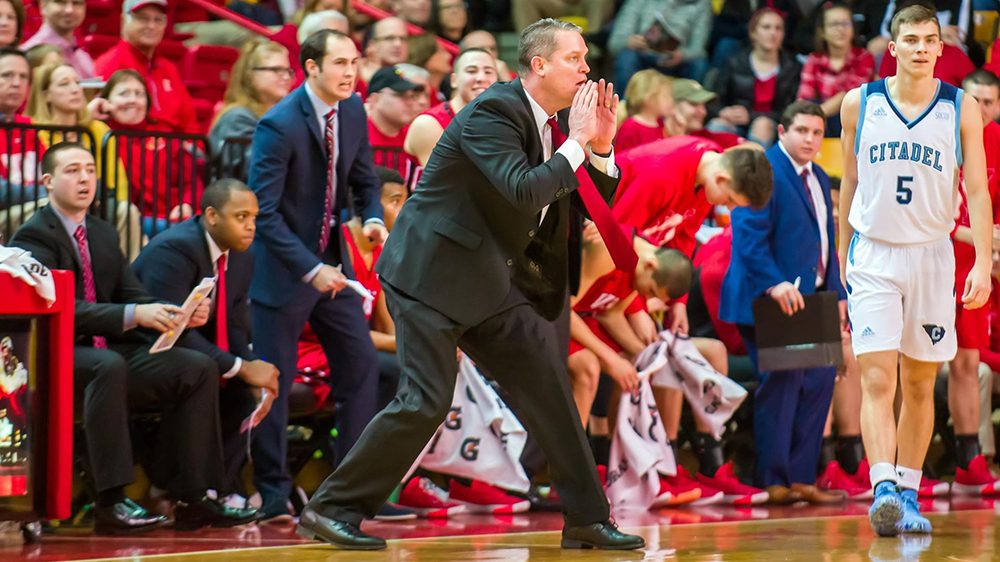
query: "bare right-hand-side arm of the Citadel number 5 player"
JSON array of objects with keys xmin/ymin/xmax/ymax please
[{"xmin": 961, "ymin": 96, "xmax": 993, "ymax": 309}]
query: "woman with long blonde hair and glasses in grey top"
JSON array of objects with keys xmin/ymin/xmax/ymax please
[{"xmin": 208, "ymin": 40, "xmax": 293, "ymax": 181}]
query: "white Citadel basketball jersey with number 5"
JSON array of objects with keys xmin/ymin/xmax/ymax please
[{"xmin": 848, "ymin": 79, "xmax": 962, "ymax": 245}]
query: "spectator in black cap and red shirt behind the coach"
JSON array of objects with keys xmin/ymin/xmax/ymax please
[{"xmin": 365, "ymin": 66, "xmax": 424, "ymax": 185}]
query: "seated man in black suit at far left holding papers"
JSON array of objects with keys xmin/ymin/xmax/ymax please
[{"xmin": 11, "ymin": 143, "xmax": 257, "ymax": 534}]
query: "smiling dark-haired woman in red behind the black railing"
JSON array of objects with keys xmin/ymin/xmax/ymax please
[{"xmin": 99, "ymin": 69, "xmax": 204, "ymax": 237}]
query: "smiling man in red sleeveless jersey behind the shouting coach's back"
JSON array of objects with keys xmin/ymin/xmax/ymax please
[{"xmin": 403, "ymin": 49, "xmax": 497, "ymax": 166}]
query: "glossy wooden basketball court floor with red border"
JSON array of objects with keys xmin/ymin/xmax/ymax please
[{"xmin": 0, "ymin": 498, "xmax": 1000, "ymax": 562}]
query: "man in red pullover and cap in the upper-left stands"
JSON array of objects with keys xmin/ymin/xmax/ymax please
[{"xmin": 94, "ymin": 0, "xmax": 202, "ymax": 134}]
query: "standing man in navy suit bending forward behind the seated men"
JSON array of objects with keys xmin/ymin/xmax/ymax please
[{"xmin": 248, "ymin": 29, "xmax": 387, "ymax": 520}]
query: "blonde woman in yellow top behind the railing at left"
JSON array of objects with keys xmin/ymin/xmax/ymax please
[{"xmin": 26, "ymin": 63, "xmax": 142, "ymax": 258}]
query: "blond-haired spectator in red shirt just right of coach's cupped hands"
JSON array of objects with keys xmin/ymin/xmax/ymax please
[{"xmin": 615, "ymin": 68, "xmax": 674, "ymax": 152}]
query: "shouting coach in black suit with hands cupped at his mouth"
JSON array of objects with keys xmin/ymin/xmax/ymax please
[{"xmin": 297, "ymin": 19, "xmax": 644, "ymax": 550}]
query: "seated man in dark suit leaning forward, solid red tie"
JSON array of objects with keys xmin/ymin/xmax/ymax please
[{"xmin": 132, "ymin": 179, "xmax": 278, "ymax": 495}]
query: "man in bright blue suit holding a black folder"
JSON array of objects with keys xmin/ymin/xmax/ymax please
[{"xmin": 719, "ymin": 101, "xmax": 847, "ymax": 503}]
